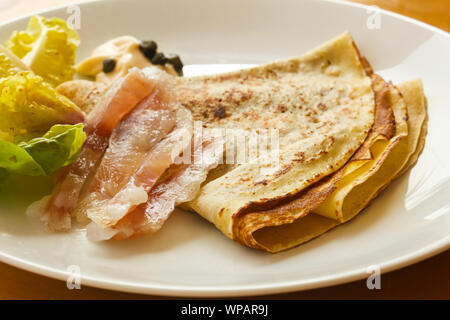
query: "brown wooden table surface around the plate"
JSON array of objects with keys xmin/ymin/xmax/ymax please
[{"xmin": 0, "ymin": 0, "xmax": 450, "ymax": 299}]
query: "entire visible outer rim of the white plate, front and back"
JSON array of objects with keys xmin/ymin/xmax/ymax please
[{"xmin": 0, "ymin": 0, "xmax": 450, "ymax": 298}]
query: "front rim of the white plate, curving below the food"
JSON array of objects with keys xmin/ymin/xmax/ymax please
[{"xmin": 0, "ymin": 235, "xmax": 450, "ymax": 298}]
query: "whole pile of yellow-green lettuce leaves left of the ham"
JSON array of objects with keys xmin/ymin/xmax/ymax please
[{"xmin": 0, "ymin": 17, "xmax": 86, "ymax": 181}]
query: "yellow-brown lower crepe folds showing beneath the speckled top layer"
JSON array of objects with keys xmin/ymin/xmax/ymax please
[{"xmin": 235, "ymin": 80, "xmax": 426, "ymax": 252}]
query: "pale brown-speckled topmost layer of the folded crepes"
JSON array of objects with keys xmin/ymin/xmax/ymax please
[{"xmin": 183, "ymin": 33, "xmax": 375, "ymax": 238}]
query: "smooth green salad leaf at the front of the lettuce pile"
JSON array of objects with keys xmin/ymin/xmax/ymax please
[{"xmin": 0, "ymin": 123, "xmax": 86, "ymax": 179}]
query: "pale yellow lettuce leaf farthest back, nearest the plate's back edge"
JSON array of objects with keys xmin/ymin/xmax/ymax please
[{"xmin": 6, "ymin": 16, "xmax": 80, "ymax": 86}]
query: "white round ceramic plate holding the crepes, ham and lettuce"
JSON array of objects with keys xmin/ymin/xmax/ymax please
[{"xmin": 0, "ymin": 0, "xmax": 450, "ymax": 297}]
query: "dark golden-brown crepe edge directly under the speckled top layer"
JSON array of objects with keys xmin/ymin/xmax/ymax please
[{"xmin": 233, "ymin": 75, "xmax": 395, "ymax": 251}]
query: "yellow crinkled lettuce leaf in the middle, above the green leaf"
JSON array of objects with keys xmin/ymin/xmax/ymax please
[{"xmin": 0, "ymin": 72, "xmax": 84, "ymax": 143}]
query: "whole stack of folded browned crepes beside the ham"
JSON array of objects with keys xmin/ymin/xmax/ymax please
[{"xmin": 55, "ymin": 33, "xmax": 427, "ymax": 252}]
